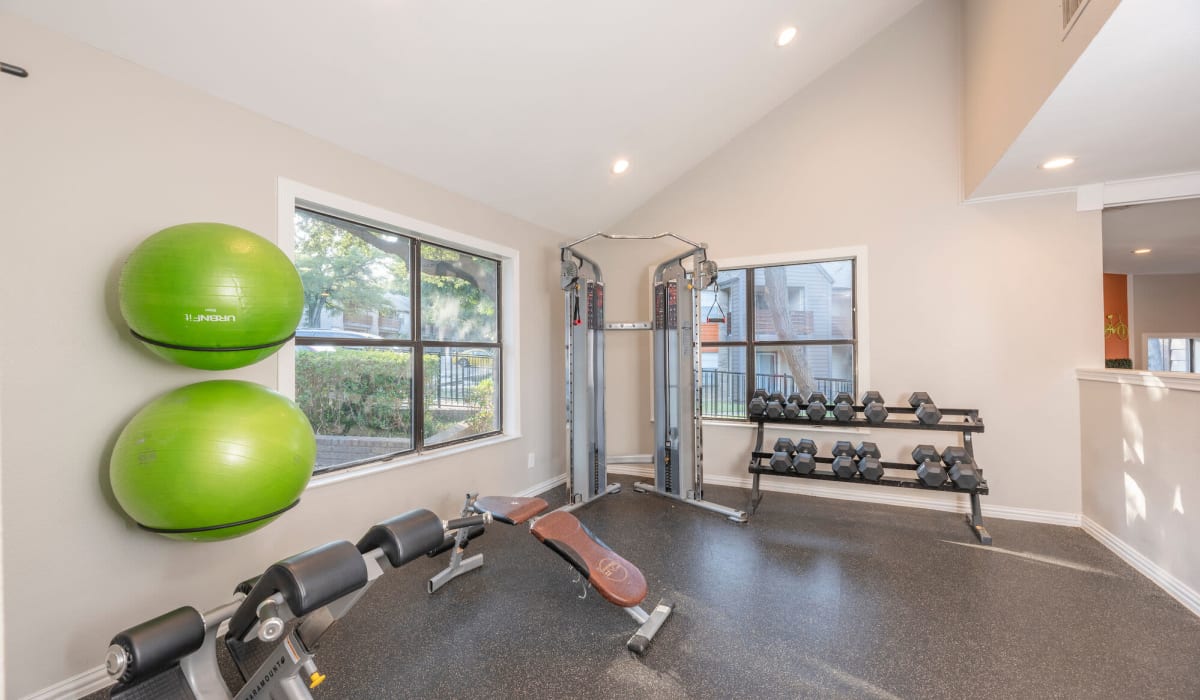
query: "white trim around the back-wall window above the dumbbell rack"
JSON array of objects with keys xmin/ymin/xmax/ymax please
[{"xmin": 703, "ymin": 245, "xmax": 871, "ymax": 433}]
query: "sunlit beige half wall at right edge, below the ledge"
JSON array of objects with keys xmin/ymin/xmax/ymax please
[{"xmin": 1079, "ymin": 370, "xmax": 1200, "ymax": 615}]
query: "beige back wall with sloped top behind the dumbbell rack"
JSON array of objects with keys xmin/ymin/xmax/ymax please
[{"xmin": 598, "ymin": 0, "xmax": 1103, "ymax": 514}]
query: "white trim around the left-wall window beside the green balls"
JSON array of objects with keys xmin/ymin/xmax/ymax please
[{"xmin": 276, "ymin": 178, "xmax": 522, "ymax": 489}]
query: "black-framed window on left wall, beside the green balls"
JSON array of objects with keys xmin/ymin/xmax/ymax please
[{"xmin": 294, "ymin": 207, "xmax": 502, "ymax": 473}]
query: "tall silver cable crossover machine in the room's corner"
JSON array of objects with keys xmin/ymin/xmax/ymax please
[{"xmin": 562, "ymin": 232, "xmax": 746, "ymax": 522}]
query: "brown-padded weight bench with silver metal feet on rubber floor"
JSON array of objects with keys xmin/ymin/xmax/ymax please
[{"xmin": 430, "ymin": 493, "xmax": 673, "ymax": 656}]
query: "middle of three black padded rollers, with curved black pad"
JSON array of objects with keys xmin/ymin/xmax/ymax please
[{"xmin": 229, "ymin": 540, "xmax": 367, "ymax": 639}]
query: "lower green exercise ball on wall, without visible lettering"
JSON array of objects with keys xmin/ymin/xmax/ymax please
[{"xmin": 108, "ymin": 379, "xmax": 317, "ymax": 540}]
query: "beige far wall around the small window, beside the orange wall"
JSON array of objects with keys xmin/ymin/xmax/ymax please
[{"xmin": 1129, "ymin": 275, "xmax": 1200, "ymax": 370}]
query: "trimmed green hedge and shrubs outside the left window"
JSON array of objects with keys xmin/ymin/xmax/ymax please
[{"xmin": 295, "ymin": 349, "xmax": 496, "ymax": 437}]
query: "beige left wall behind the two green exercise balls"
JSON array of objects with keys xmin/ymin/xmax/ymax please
[{"xmin": 0, "ymin": 16, "xmax": 564, "ymax": 698}]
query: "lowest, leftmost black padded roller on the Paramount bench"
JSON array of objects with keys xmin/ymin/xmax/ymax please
[{"xmin": 110, "ymin": 605, "xmax": 204, "ymax": 683}]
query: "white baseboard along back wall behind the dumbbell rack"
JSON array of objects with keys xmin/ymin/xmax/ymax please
[{"xmin": 608, "ymin": 461, "xmax": 1079, "ymax": 527}]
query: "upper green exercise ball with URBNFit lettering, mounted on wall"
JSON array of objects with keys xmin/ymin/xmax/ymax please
[{"xmin": 120, "ymin": 223, "xmax": 304, "ymax": 370}]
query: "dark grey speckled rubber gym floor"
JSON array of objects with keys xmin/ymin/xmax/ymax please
[{"xmin": 87, "ymin": 478, "xmax": 1200, "ymax": 699}]
